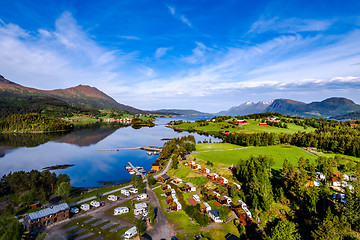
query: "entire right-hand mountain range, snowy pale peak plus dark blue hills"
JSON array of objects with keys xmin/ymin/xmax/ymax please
[{"xmin": 218, "ymin": 97, "xmax": 360, "ymax": 119}]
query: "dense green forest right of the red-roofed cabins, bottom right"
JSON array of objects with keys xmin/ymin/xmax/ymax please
[{"xmin": 230, "ymin": 156, "xmax": 360, "ymax": 240}]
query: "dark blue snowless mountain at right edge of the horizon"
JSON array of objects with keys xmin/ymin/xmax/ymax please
[{"xmin": 265, "ymin": 97, "xmax": 360, "ymax": 118}]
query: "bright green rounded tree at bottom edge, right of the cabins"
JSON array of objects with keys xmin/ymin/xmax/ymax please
[{"xmin": 268, "ymin": 220, "xmax": 300, "ymax": 240}]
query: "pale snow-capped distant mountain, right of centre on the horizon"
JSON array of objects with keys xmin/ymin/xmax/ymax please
[{"xmin": 215, "ymin": 100, "xmax": 273, "ymax": 116}]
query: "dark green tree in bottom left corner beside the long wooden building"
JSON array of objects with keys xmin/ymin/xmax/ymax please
[{"xmin": 0, "ymin": 216, "xmax": 23, "ymax": 240}]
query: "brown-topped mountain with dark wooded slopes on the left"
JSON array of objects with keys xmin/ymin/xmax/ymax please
[{"xmin": 0, "ymin": 75, "xmax": 143, "ymax": 116}]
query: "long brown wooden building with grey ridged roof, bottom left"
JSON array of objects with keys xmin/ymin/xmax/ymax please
[{"xmin": 23, "ymin": 203, "xmax": 70, "ymax": 232}]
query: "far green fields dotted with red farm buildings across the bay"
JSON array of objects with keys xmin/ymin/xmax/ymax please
[{"xmin": 173, "ymin": 119, "xmax": 315, "ymax": 134}]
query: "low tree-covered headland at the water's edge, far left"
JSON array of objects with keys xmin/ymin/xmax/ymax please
[{"xmin": 0, "ymin": 113, "xmax": 73, "ymax": 133}]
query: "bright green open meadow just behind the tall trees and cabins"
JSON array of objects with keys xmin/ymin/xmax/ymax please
[{"xmin": 194, "ymin": 145, "xmax": 316, "ymax": 169}]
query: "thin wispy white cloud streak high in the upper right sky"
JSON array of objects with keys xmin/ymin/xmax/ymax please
[{"xmin": 249, "ymin": 17, "xmax": 333, "ymax": 33}]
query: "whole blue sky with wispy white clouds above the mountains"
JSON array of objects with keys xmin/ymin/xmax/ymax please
[{"xmin": 0, "ymin": 0, "xmax": 360, "ymax": 112}]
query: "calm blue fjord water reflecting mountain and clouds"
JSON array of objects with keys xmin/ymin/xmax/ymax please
[{"xmin": 0, "ymin": 116, "xmax": 220, "ymax": 187}]
